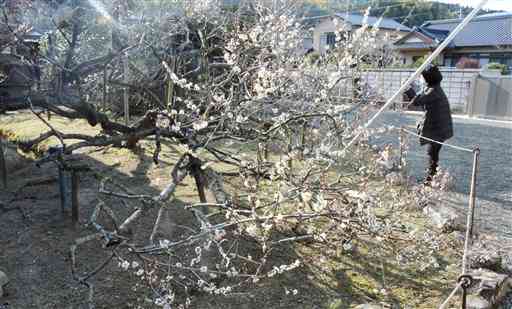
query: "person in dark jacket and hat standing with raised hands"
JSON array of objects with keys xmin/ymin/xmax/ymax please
[{"xmin": 406, "ymin": 65, "xmax": 453, "ymax": 185}]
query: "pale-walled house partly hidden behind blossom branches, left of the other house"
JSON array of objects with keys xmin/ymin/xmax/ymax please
[{"xmin": 304, "ymin": 13, "xmax": 411, "ymax": 54}]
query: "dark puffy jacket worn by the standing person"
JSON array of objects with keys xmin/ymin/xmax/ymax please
[{"xmin": 411, "ymin": 84, "xmax": 453, "ymax": 145}]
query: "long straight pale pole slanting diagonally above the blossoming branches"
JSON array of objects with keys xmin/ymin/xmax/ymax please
[{"xmin": 343, "ymin": 0, "xmax": 488, "ymax": 153}]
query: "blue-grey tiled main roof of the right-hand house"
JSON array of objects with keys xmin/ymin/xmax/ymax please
[{"xmin": 421, "ymin": 13, "xmax": 512, "ymax": 47}]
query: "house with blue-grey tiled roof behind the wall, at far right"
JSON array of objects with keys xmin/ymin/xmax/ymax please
[{"xmin": 394, "ymin": 13, "xmax": 512, "ymax": 68}]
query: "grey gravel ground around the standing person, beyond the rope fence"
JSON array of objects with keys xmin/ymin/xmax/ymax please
[{"xmin": 371, "ymin": 112, "xmax": 512, "ymax": 237}]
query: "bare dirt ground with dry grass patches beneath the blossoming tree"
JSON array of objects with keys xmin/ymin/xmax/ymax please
[{"xmin": 0, "ymin": 114, "xmax": 462, "ymax": 309}]
